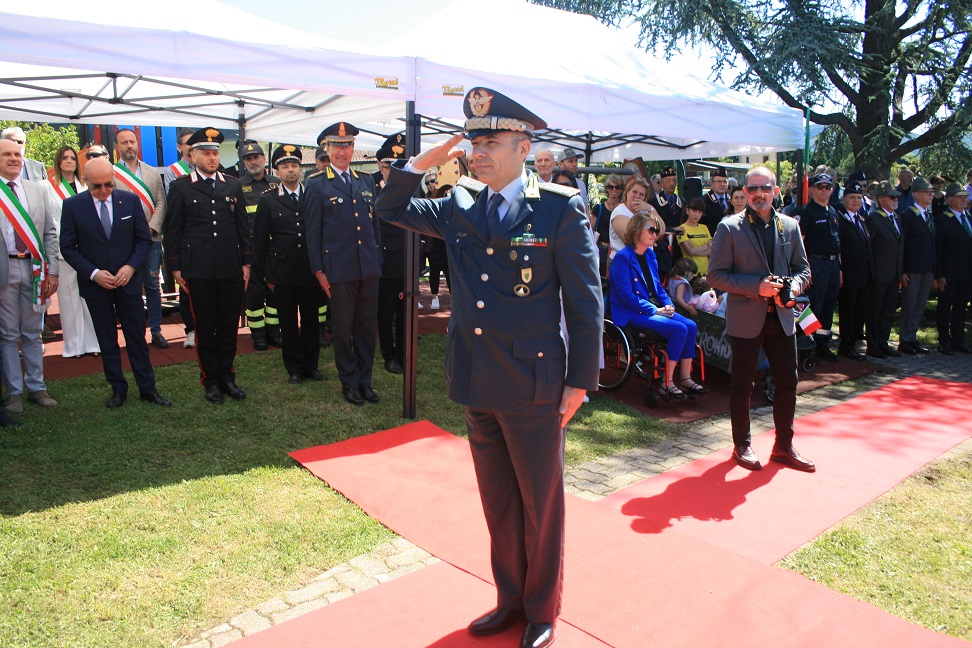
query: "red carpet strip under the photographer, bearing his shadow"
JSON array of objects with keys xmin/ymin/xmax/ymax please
[{"xmin": 604, "ymin": 378, "xmax": 972, "ymax": 564}]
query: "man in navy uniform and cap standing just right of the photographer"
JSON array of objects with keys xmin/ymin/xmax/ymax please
[{"xmin": 794, "ymin": 173, "xmax": 840, "ymax": 362}]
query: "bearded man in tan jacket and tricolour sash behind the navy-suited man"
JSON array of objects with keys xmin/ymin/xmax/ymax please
[{"xmin": 115, "ymin": 128, "xmax": 169, "ymax": 349}]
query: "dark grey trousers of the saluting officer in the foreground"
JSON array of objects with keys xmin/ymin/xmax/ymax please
[{"xmin": 466, "ymin": 407, "xmax": 566, "ymax": 623}]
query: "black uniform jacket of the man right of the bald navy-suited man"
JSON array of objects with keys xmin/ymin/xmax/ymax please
[{"xmin": 165, "ymin": 171, "xmax": 253, "ymax": 279}]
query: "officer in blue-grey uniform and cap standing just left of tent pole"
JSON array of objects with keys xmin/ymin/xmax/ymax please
[{"xmin": 304, "ymin": 122, "xmax": 381, "ymax": 405}]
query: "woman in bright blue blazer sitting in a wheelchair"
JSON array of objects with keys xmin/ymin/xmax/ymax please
[{"xmin": 610, "ymin": 210, "xmax": 709, "ymax": 400}]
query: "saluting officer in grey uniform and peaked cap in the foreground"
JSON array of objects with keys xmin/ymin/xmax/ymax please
[{"xmin": 378, "ymin": 88, "xmax": 603, "ymax": 648}]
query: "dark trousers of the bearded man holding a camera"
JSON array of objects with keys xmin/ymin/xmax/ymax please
[{"xmin": 729, "ymin": 312, "xmax": 797, "ymax": 449}]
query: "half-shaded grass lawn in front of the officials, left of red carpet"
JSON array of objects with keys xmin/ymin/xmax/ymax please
[{"xmin": 0, "ymin": 335, "xmax": 676, "ymax": 648}]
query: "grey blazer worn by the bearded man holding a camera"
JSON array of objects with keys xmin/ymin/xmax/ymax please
[{"xmin": 707, "ymin": 208, "xmax": 810, "ymax": 339}]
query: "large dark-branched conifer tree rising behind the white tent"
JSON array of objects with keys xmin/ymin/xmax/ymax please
[{"xmin": 534, "ymin": 0, "xmax": 972, "ymax": 177}]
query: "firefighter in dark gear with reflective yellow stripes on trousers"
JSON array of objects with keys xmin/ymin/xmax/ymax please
[{"xmin": 239, "ymin": 140, "xmax": 283, "ymax": 351}]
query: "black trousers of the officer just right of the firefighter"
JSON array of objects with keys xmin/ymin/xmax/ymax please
[{"xmin": 272, "ymin": 284, "xmax": 323, "ymax": 376}]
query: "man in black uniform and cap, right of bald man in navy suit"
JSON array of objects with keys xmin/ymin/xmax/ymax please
[{"xmin": 165, "ymin": 127, "xmax": 253, "ymax": 403}]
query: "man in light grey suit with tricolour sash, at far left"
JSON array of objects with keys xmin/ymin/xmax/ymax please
[{"xmin": 0, "ymin": 139, "xmax": 58, "ymax": 413}]
